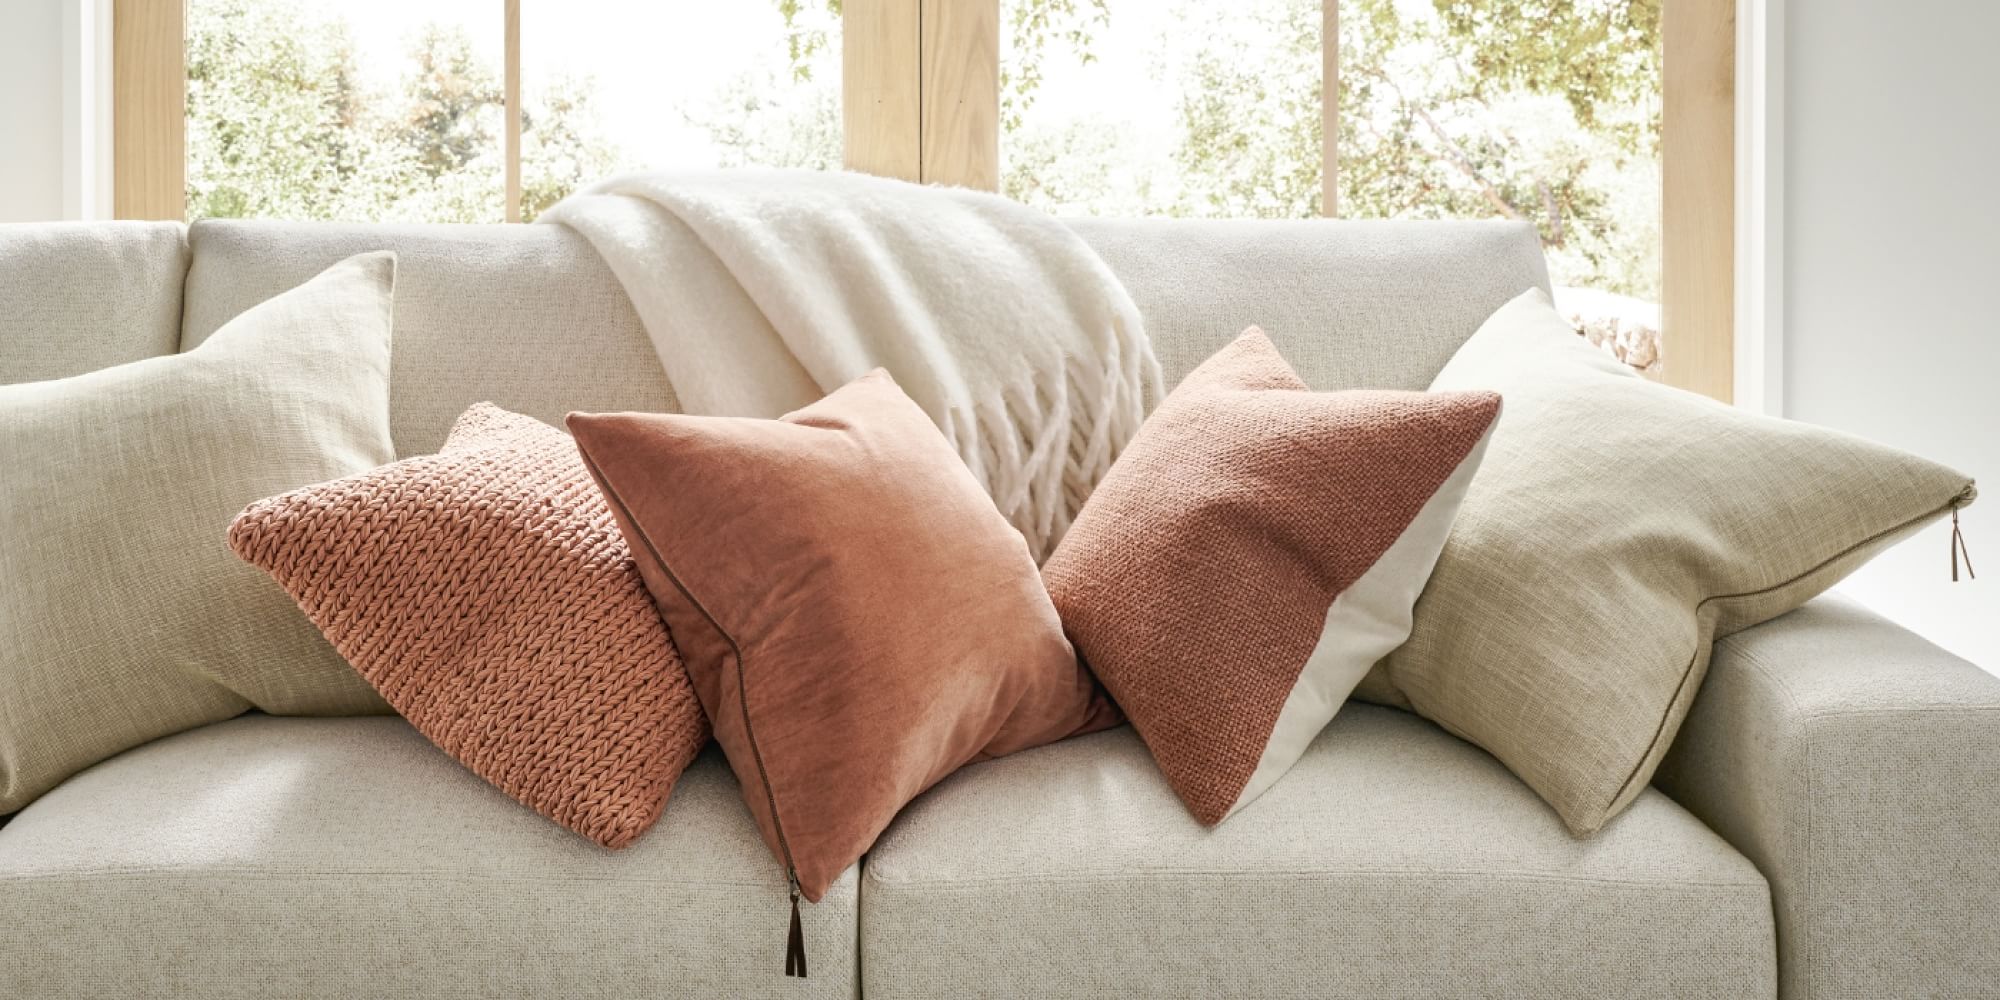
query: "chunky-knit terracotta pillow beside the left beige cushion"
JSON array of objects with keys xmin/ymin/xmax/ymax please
[{"xmin": 230, "ymin": 402, "xmax": 708, "ymax": 848}]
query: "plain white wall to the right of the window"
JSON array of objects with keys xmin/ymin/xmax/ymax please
[{"xmin": 1782, "ymin": 0, "xmax": 2000, "ymax": 674}]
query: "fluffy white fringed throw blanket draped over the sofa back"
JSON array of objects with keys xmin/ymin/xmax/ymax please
[{"xmin": 542, "ymin": 170, "xmax": 1162, "ymax": 562}]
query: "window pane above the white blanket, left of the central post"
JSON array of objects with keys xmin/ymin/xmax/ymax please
[{"xmin": 520, "ymin": 0, "xmax": 840, "ymax": 218}]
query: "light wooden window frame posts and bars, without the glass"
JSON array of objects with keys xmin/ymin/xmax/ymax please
[{"xmin": 112, "ymin": 0, "xmax": 1738, "ymax": 402}]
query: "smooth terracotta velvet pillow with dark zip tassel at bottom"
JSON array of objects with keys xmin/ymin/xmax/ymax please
[{"xmin": 570, "ymin": 370, "xmax": 1116, "ymax": 902}]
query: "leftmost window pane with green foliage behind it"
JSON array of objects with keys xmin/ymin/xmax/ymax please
[{"xmin": 188, "ymin": 0, "xmax": 504, "ymax": 222}]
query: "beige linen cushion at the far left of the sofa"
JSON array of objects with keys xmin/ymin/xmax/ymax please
[{"xmin": 0, "ymin": 254, "xmax": 396, "ymax": 814}]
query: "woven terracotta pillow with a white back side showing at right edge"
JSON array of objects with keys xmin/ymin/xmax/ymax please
[{"xmin": 1042, "ymin": 328, "xmax": 1500, "ymax": 824}]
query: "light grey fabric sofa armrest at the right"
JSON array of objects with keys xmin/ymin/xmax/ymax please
[{"xmin": 1654, "ymin": 598, "xmax": 2000, "ymax": 1000}]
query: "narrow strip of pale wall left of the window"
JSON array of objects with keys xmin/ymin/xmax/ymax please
[{"xmin": 0, "ymin": 0, "xmax": 72, "ymax": 222}]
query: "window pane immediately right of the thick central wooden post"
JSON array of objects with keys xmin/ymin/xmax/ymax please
[{"xmin": 1000, "ymin": 0, "xmax": 1320, "ymax": 218}]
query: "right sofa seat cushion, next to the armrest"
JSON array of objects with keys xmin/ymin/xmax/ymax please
[{"xmin": 860, "ymin": 704, "xmax": 1776, "ymax": 1000}]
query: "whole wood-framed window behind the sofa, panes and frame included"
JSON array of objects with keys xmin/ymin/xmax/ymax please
[{"xmin": 112, "ymin": 0, "xmax": 1736, "ymax": 398}]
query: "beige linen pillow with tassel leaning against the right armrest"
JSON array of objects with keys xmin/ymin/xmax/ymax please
[{"xmin": 1356, "ymin": 290, "xmax": 1974, "ymax": 834}]
